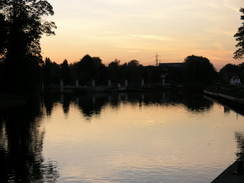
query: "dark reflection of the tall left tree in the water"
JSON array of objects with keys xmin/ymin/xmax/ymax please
[{"xmin": 0, "ymin": 98, "xmax": 58, "ymax": 183}]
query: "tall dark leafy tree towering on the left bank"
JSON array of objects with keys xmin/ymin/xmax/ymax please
[{"xmin": 0, "ymin": 0, "xmax": 56, "ymax": 92}]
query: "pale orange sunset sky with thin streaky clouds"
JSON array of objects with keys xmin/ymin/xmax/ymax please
[{"xmin": 41, "ymin": 0, "xmax": 244, "ymax": 69}]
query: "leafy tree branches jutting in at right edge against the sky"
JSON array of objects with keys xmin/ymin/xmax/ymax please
[{"xmin": 233, "ymin": 8, "xmax": 244, "ymax": 59}]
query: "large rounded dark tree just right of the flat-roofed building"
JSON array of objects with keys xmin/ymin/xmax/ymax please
[{"xmin": 183, "ymin": 55, "xmax": 217, "ymax": 83}]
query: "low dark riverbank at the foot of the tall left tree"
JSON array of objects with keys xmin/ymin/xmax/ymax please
[{"xmin": 0, "ymin": 93, "xmax": 26, "ymax": 109}]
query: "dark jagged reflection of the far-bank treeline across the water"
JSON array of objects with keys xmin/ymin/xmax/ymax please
[{"xmin": 40, "ymin": 92, "xmax": 213, "ymax": 120}]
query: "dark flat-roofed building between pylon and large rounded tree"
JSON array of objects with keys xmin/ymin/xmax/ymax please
[{"xmin": 159, "ymin": 63, "xmax": 184, "ymax": 84}]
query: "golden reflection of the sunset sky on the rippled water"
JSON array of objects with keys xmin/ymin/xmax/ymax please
[{"xmin": 43, "ymin": 103, "xmax": 244, "ymax": 182}]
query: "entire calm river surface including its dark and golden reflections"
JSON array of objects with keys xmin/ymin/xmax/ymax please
[{"xmin": 0, "ymin": 93, "xmax": 244, "ymax": 183}]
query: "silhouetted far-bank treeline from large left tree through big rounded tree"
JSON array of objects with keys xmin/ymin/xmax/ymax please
[{"xmin": 37, "ymin": 55, "xmax": 218, "ymax": 86}]
